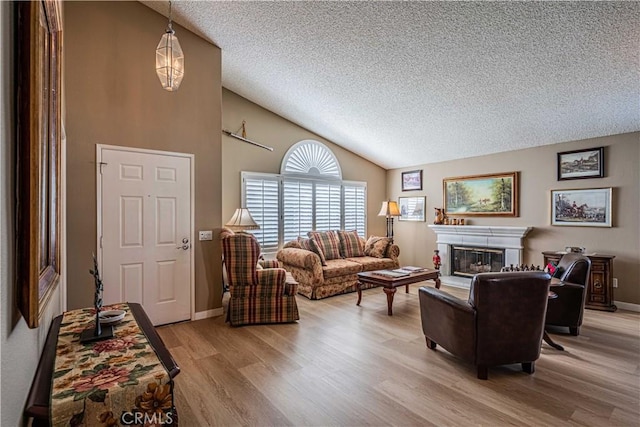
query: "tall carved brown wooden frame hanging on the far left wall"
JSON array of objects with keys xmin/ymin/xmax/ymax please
[{"xmin": 16, "ymin": 0, "xmax": 62, "ymax": 328}]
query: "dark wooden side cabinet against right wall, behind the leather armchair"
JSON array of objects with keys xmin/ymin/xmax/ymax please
[{"xmin": 542, "ymin": 251, "xmax": 618, "ymax": 311}]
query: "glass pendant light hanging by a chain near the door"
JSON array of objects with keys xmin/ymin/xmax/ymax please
[{"xmin": 156, "ymin": 2, "xmax": 184, "ymax": 92}]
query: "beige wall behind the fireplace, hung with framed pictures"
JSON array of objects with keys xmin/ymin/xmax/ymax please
[{"xmin": 387, "ymin": 132, "xmax": 640, "ymax": 304}]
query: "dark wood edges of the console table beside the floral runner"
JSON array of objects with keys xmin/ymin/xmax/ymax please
[{"xmin": 24, "ymin": 303, "xmax": 180, "ymax": 426}]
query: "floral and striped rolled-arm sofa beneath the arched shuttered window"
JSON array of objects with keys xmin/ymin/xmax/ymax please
[{"xmin": 276, "ymin": 230, "xmax": 400, "ymax": 299}]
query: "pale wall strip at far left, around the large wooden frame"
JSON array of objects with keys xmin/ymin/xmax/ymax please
[{"xmin": 0, "ymin": 2, "xmax": 62, "ymax": 426}]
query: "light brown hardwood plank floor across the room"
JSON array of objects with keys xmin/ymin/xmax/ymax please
[{"xmin": 158, "ymin": 282, "xmax": 640, "ymax": 427}]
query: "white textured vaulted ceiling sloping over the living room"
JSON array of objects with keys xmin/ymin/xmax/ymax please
[{"xmin": 142, "ymin": 1, "xmax": 640, "ymax": 169}]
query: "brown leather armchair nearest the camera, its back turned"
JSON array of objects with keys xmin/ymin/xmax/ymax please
[{"xmin": 419, "ymin": 271, "xmax": 551, "ymax": 380}]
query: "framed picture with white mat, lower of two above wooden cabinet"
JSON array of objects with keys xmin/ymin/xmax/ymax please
[{"xmin": 551, "ymin": 188, "xmax": 612, "ymax": 227}]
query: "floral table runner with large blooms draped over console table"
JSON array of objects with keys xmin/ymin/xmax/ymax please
[{"xmin": 50, "ymin": 304, "xmax": 174, "ymax": 426}]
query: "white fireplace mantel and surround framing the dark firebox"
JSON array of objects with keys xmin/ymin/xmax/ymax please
[{"xmin": 429, "ymin": 224, "xmax": 533, "ymax": 287}]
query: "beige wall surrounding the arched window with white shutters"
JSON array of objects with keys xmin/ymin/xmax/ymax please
[{"xmin": 222, "ymin": 89, "xmax": 386, "ymax": 236}]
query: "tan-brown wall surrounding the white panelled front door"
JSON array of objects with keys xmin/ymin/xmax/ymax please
[{"xmin": 65, "ymin": 2, "xmax": 222, "ymax": 311}]
